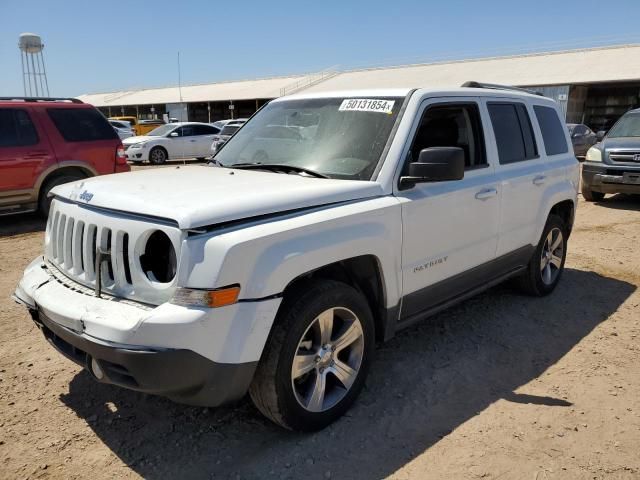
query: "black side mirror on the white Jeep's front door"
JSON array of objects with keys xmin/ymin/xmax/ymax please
[{"xmin": 400, "ymin": 147, "xmax": 464, "ymax": 188}]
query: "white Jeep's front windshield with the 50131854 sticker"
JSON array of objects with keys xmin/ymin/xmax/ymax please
[{"xmin": 215, "ymin": 97, "xmax": 403, "ymax": 180}]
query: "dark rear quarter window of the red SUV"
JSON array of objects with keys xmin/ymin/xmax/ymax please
[{"xmin": 47, "ymin": 108, "xmax": 118, "ymax": 142}]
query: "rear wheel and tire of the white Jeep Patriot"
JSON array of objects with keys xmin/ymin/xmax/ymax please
[{"xmin": 519, "ymin": 215, "xmax": 567, "ymax": 297}]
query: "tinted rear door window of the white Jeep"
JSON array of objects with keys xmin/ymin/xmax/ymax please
[{"xmin": 487, "ymin": 102, "xmax": 538, "ymax": 165}]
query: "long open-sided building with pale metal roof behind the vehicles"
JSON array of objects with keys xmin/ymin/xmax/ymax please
[{"xmin": 79, "ymin": 45, "xmax": 640, "ymax": 128}]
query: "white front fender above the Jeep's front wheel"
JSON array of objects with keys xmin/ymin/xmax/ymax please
[{"xmin": 184, "ymin": 196, "xmax": 402, "ymax": 306}]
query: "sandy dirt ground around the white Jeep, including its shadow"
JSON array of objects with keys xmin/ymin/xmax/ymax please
[{"xmin": 0, "ymin": 171, "xmax": 640, "ymax": 480}]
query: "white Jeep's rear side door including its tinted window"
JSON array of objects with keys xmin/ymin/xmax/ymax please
[{"xmin": 486, "ymin": 98, "xmax": 550, "ymax": 256}]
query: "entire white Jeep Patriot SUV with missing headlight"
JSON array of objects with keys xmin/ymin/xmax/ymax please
[{"xmin": 15, "ymin": 84, "xmax": 578, "ymax": 430}]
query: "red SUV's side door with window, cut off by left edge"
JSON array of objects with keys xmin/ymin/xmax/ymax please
[{"xmin": 0, "ymin": 108, "xmax": 55, "ymax": 198}]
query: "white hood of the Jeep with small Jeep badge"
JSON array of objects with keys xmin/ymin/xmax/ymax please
[{"xmin": 53, "ymin": 165, "xmax": 383, "ymax": 229}]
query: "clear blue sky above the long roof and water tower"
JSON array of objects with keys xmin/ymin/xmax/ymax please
[{"xmin": 0, "ymin": 0, "xmax": 640, "ymax": 96}]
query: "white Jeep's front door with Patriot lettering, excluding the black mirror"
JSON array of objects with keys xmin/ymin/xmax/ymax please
[{"xmin": 397, "ymin": 97, "xmax": 500, "ymax": 322}]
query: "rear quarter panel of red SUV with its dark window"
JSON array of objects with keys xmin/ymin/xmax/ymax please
[{"xmin": 43, "ymin": 104, "xmax": 120, "ymax": 175}]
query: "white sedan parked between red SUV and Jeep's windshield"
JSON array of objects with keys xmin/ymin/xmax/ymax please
[{"xmin": 122, "ymin": 122, "xmax": 220, "ymax": 164}]
